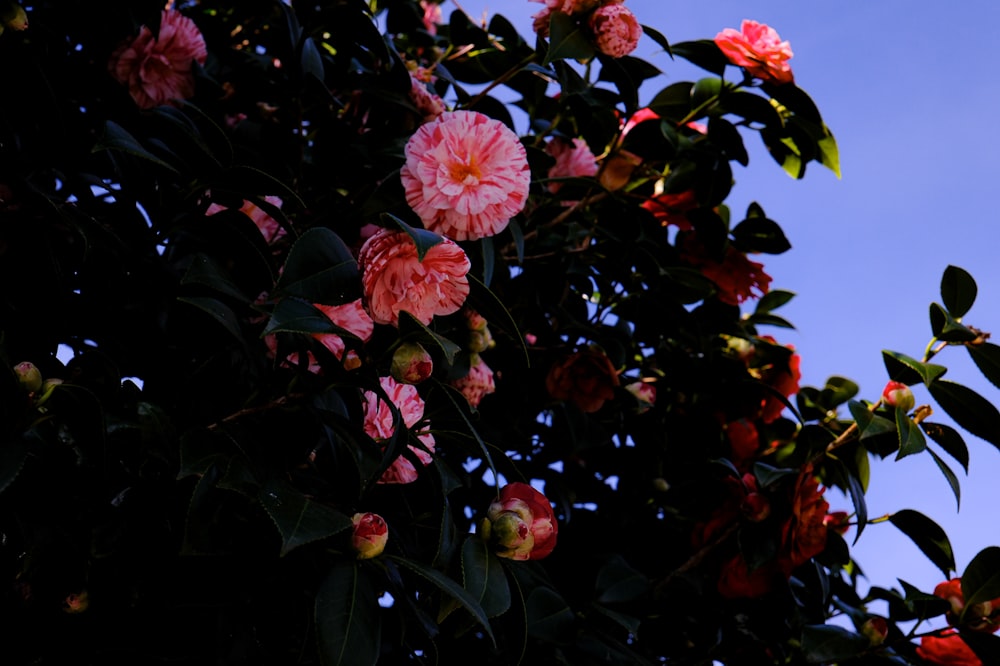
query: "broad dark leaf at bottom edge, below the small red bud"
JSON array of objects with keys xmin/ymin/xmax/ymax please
[{"xmin": 315, "ymin": 561, "xmax": 382, "ymax": 666}]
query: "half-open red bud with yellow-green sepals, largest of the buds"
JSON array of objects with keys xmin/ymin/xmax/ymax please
[{"xmin": 481, "ymin": 482, "xmax": 559, "ymax": 560}]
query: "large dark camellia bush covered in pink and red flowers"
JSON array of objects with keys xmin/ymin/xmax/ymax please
[{"xmin": 9, "ymin": 0, "xmax": 1000, "ymax": 666}]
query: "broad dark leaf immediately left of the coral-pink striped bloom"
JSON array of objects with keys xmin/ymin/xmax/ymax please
[{"xmin": 276, "ymin": 227, "xmax": 358, "ymax": 304}]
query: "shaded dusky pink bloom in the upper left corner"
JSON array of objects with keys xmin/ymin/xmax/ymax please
[{"xmin": 108, "ymin": 9, "xmax": 208, "ymax": 109}]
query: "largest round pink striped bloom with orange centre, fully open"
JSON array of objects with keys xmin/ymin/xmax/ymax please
[{"xmin": 400, "ymin": 111, "xmax": 531, "ymax": 240}]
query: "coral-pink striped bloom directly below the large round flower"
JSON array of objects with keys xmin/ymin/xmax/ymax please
[{"xmin": 358, "ymin": 227, "xmax": 472, "ymax": 326}]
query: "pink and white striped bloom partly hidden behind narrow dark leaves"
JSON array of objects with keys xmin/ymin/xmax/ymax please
[{"xmin": 362, "ymin": 377, "xmax": 434, "ymax": 483}]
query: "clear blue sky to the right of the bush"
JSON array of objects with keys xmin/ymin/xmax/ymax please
[{"xmin": 458, "ymin": 0, "xmax": 1000, "ymax": 591}]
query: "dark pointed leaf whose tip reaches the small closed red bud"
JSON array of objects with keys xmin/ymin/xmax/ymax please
[{"xmin": 259, "ymin": 479, "xmax": 352, "ymax": 556}]
